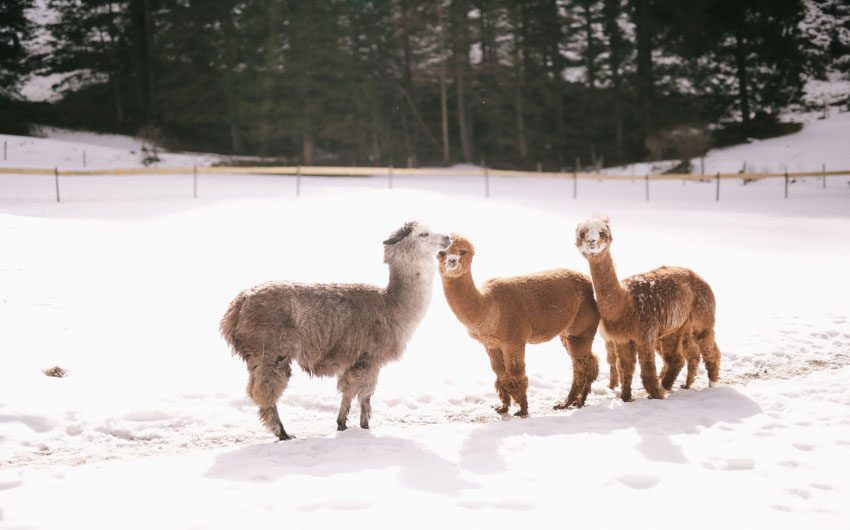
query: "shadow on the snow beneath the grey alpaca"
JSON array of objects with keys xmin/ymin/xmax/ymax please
[{"xmin": 205, "ymin": 433, "xmax": 478, "ymax": 495}]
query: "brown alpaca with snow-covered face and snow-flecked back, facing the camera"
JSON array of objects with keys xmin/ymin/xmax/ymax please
[{"xmin": 576, "ymin": 218, "xmax": 720, "ymax": 401}]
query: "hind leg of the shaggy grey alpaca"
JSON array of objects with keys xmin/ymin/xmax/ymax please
[{"xmin": 247, "ymin": 355, "xmax": 294, "ymax": 440}]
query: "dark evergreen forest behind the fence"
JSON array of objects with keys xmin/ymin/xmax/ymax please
[{"xmin": 0, "ymin": 0, "xmax": 850, "ymax": 169}]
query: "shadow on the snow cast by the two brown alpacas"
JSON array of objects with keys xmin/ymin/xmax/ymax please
[{"xmin": 460, "ymin": 387, "xmax": 762, "ymax": 473}]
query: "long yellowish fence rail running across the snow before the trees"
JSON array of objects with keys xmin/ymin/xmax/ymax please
[{"xmin": 0, "ymin": 166, "xmax": 850, "ymax": 181}]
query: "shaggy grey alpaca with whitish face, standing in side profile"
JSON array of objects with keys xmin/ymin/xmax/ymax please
[{"xmin": 221, "ymin": 222, "xmax": 450, "ymax": 440}]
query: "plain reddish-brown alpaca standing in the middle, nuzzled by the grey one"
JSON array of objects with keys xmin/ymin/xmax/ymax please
[{"xmin": 439, "ymin": 234, "xmax": 599, "ymax": 416}]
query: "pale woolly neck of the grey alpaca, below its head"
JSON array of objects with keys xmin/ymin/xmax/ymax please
[{"xmin": 384, "ymin": 263, "xmax": 436, "ymax": 326}]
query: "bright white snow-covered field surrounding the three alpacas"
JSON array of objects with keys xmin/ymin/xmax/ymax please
[{"xmin": 0, "ymin": 114, "xmax": 850, "ymax": 529}]
